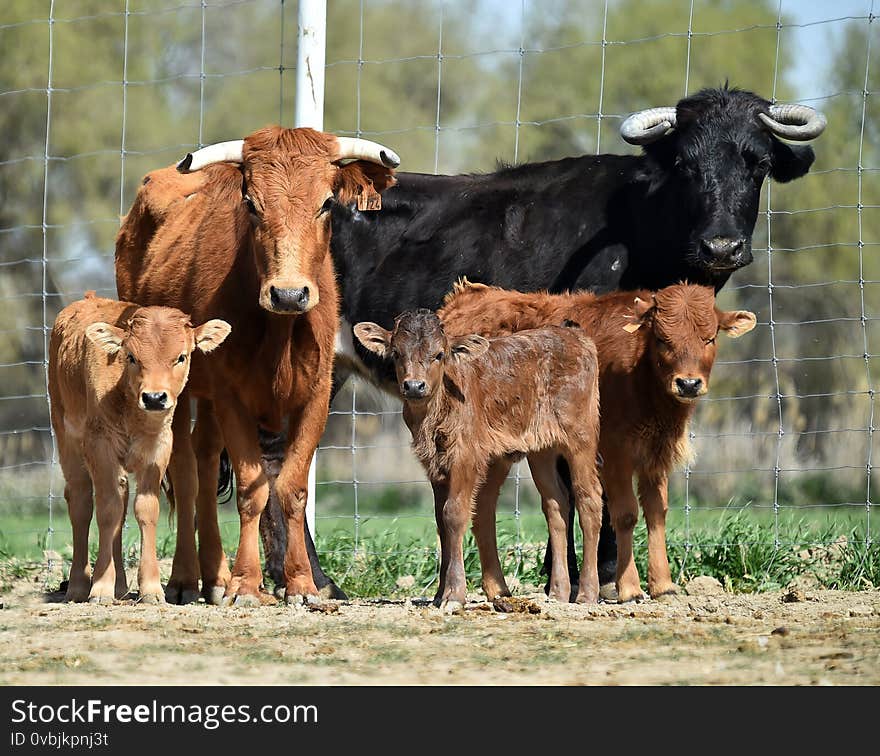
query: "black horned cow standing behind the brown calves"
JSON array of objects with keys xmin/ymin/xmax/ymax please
[{"xmin": 264, "ymin": 85, "xmax": 825, "ymax": 604}]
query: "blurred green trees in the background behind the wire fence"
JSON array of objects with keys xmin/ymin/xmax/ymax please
[{"xmin": 0, "ymin": 0, "xmax": 880, "ymax": 508}]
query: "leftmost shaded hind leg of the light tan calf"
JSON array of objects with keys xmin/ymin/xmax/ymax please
[{"xmin": 58, "ymin": 436, "xmax": 92, "ymax": 601}]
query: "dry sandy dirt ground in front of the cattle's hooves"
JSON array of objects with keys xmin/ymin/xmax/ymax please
[{"xmin": 0, "ymin": 579, "xmax": 880, "ymax": 685}]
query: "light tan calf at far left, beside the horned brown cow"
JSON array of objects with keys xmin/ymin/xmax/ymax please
[{"xmin": 49, "ymin": 292, "xmax": 229, "ymax": 603}]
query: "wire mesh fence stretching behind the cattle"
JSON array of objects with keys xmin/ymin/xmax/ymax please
[{"xmin": 0, "ymin": 0, "xmax": 880, "ymax": 592}]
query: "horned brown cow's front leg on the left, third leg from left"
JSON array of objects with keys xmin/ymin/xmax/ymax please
[{"xmin": 214, "ymin": 396, "xmax": 269, "ymax": 606}]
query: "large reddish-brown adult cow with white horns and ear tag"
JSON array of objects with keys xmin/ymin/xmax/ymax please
[{"xmin": 116, "ymin": 127, "xmax": 399, "ymax": 603}]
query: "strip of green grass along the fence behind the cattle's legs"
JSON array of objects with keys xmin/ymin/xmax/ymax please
[{"xmin": 0, "ymin": 491, "xmax": 880, "ymax": 597}]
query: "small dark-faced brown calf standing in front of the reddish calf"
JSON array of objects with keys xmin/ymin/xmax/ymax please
[{"xmin": 354, "ymin": 310, "xmax": 602, "ymax": 606}]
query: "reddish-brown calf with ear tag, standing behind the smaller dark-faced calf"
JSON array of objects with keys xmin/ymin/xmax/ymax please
[{"xmin": 439, "ymin": 281, "xmax": 755, "ymax": 602}]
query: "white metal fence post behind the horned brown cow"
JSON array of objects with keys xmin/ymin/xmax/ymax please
[{"xmin": 293, "ymin": 0, "xmax": 327, "ymax": 538}]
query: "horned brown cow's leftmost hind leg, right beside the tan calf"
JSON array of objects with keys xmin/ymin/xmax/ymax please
[{"xmin": 165, "ymin": 392, "xmax": 199, "ymax": 604}]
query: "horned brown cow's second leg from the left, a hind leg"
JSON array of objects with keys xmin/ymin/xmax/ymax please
[{"xmin": 192, "ymin": 399, "xmax": 232, "ymax": 605}]
